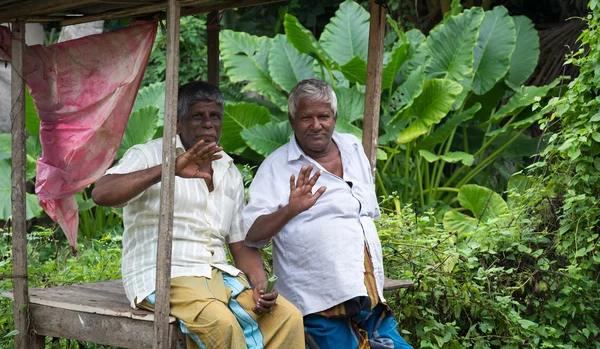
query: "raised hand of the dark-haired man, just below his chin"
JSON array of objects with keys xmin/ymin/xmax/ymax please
[{"xmin": 175, "ymin": 140, "xmax": 223, "ymax": 180}]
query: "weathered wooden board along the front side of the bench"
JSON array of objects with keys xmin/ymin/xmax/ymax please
[{"xmin": 31, "ymin": 304, "xmax": 185, "ymax": 349}]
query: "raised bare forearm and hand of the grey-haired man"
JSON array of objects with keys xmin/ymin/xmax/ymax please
[{"xmin": 246, "ymin": 165, "xmax": 327, "ymax": 243}]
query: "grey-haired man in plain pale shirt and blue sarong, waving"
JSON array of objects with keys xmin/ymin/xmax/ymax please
[{"xmin": 243, "ymin": 79, "xmax": 411, "ymax": 349}]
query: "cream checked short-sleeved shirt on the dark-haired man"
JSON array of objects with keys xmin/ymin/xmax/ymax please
[{"xmin": 106, "ymin": 136, "xmax": 245, "ymax": 308}]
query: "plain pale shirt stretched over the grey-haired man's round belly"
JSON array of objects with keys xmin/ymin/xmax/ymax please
[{"xmin": 243, "ymin": 132, "xmax": 384, "ymax": 316}]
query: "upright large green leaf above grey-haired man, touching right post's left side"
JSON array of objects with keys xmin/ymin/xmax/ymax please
[{"xmin": 319, "ymin": 0, "xmax": 370, "ymax": 65}]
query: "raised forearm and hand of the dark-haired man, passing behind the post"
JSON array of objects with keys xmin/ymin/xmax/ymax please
[{"xmin": 92, "ymin": 140, "xmax": 223, "ymax": 206}]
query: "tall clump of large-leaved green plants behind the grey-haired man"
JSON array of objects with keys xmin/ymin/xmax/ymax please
[{"xmin": 220, "ymin": 0, "xmax": 558, "ymax": 215}]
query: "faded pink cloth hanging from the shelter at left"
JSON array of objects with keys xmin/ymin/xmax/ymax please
[{"xmin": 0, "ymin": 22, "xmax": 157, "ymax": 248}]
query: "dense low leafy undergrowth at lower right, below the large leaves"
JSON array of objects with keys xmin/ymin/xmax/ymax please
[{"xmin": 378, "ymin": 200, "xmax": 600, "ymax": 348}]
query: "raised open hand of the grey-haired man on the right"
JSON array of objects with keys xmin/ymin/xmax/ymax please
[{"xmin": 288, "ymin": 164, "xmax": 327, "ymax": 216}]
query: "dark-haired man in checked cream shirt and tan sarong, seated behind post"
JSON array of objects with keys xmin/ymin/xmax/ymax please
[{"xmin": 92, "ymin": 82, "xmax": 304, "ymax": 348}]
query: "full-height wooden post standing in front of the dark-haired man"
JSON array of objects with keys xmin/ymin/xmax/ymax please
[{"xmin": 153, "ymin": 0, "xmax": 180, "ymax": 349}]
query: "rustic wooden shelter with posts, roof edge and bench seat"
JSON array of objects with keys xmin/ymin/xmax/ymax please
[{"xmin": 0, "ymin": 0, "xmax": 412, "ymax": 349}]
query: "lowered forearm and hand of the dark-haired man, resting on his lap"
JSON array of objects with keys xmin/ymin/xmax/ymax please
[{"xmin": 229, "ymin": 241, "xmax": 278, "ymax": 314}]
